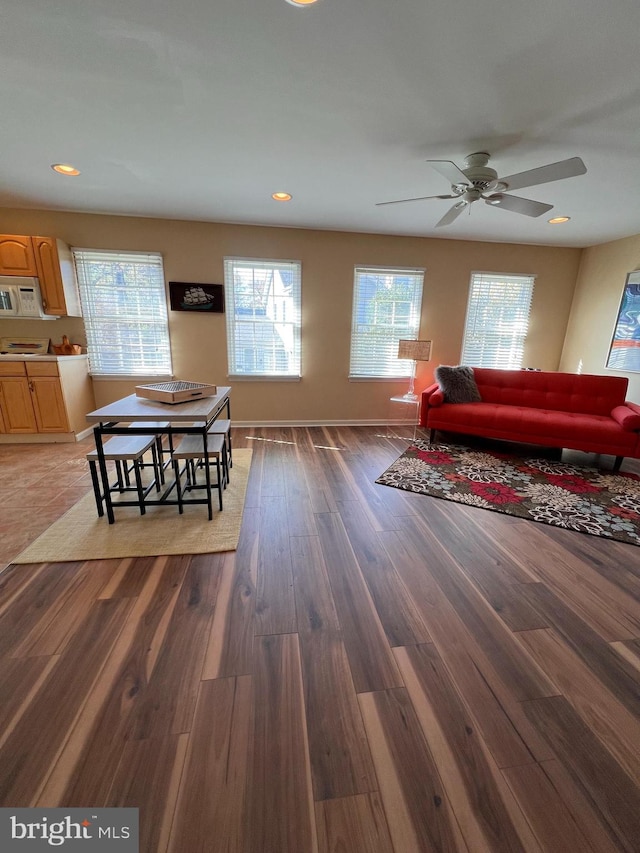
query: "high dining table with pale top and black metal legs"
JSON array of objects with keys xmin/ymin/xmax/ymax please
[{"xmin": 86, "ymin": 386, "xmax": 231, "ymax": 524}]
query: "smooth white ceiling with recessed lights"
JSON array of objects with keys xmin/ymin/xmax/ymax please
[{"xmin": 0, "ymin": 0, "xmax": 640, "ymax": 246}]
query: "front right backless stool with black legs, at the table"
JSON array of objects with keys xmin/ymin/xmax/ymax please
[{"xmin": 171, "ymin": 434, "xmax": 227, "ymax": 521}]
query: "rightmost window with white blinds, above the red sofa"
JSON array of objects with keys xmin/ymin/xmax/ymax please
[{"xmin": 460, "ymin": 273, "xmax": 535, "ymax": 369}]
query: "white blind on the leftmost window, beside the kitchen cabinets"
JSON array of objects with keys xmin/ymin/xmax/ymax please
[{"xmin": 73, "ymin": 249, "xmax": 172, "ymax": 376}]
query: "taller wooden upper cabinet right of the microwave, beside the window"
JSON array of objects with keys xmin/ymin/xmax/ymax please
[{"xmin": 31, "ymin": 237, "xmax": 82, "ymax": 317}]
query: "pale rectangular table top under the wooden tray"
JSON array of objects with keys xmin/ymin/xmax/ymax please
[{"xmin": 86, "ymin": 386, "xmax": 231, "ymax": 424}]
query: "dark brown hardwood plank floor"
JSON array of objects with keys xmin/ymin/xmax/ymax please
[{"xmin": 0, "ymin": 427, "xmax": 640, "ymax": 853}]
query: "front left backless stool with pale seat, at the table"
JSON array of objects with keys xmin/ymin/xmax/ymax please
[{"xmin": 87, "ymin": 435, "xmax": 160, "ymax": 516}]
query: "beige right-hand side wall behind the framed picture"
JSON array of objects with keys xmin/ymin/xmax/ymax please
[{"xmin": 560, "ymin": 234, "xmax": 640, "ymax": 402}]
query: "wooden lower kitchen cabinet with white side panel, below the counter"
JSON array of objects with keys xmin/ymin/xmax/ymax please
[{"xmin": 0, "ymin": 356, "xmax": 95, "ymax": 441}]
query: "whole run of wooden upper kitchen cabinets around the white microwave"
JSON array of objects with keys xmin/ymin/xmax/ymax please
[{"xmin": 0, "ymin": 234, "xmax": 82, "ymax": 317}]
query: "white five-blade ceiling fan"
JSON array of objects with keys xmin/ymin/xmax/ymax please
[{"xmin": 376, "ymin": 151, "xmax": 587, "ymax": 228}]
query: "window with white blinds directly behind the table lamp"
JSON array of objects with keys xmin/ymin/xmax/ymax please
[{"xmin": 349, "ymin": 267, "xmax": 424, "ymax": 379}]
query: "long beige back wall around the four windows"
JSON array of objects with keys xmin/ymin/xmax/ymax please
[{"xmin": 0, "ymin": 210, "xmax": 581, "ymax": 423}]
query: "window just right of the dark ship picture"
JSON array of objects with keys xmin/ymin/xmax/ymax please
[{"xmin": 224, "ymin": 258, "xmax": 301, "ymax": 378}]
